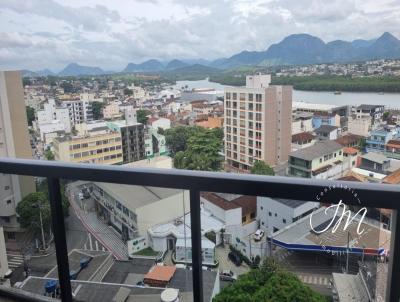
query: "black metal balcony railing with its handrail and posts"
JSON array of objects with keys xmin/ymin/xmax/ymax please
[{"xmin": 0, "ymin": 158, "xmax": 400, "ymax": 302}]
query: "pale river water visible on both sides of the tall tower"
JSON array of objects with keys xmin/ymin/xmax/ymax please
[{"xmin": 174, "ymin": 79, "xmax": 400, "ymax": 108}]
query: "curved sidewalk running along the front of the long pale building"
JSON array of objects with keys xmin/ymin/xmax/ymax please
[{"xmin": 67, "ymin": 184, "xmax": 128, "ymax": 260}]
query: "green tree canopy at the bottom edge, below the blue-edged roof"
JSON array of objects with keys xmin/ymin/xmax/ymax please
[{"xmin": 213, "ymin": 258, "xmax": 327, "ymax": 302}]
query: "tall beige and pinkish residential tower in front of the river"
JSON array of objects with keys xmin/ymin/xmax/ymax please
[{"xmin": 224, "ymin": 74, "xmax": 292, "ymax": 171}]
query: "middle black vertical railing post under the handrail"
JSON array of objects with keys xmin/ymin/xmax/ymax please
[{"xmin": 190, "ymin": 190, "xmax": 203, "ymax": 302}]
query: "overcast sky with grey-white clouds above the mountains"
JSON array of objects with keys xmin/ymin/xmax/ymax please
[{"xmin": 0, "ymin": 0, "xmax": 400, "ymax": 71}]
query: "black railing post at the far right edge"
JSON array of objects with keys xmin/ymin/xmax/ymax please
[{"xmin": 386, "ymin": 210, "xmax": 400, "ymax": 302}]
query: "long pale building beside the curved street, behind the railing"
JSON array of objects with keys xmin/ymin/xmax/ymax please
[{"xmin": 92, "ymin": 182, "xmax": 190, "ymax": 246}]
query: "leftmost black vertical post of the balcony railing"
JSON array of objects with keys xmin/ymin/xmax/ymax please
[{"xmin": 47, "ymin": 177, "xmax": 72, "ymax": 302}]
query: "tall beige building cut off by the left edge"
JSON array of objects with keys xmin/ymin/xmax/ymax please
[{"xmin": 0, "ymin": 71, "xmax": 35, "ymax": 240}]
